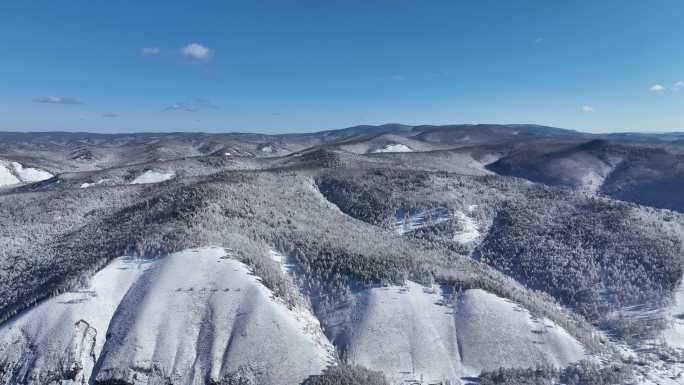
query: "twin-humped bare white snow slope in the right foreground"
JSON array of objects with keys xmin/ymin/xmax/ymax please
[{"xmin": 348, "ymin": 282, "xmax": 585, "ymax": 384}]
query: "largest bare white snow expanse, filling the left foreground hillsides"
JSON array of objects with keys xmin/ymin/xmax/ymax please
[{"xmin": 0, "ymin": 248, "xmax": 333, "ymax": 385}]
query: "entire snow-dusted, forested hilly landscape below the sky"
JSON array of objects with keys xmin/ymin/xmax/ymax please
[{"xmin": 0, "ymin": 125, "xmax": 684, "ymax": 385}]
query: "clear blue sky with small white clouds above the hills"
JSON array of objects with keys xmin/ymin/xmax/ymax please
[{"xmin": 0, "ymin": 0, "xmax": 684, "ymax": 133}]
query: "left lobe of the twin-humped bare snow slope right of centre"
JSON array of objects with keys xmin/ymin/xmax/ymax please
[{"xmin": 348, "ymin": 282, "xmax": 463, "ymax": 383}]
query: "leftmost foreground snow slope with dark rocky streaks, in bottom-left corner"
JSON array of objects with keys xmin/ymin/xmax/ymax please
[{"xmin": 0, "ymin": 257, "xmax": 150, "ymax": 384}]
